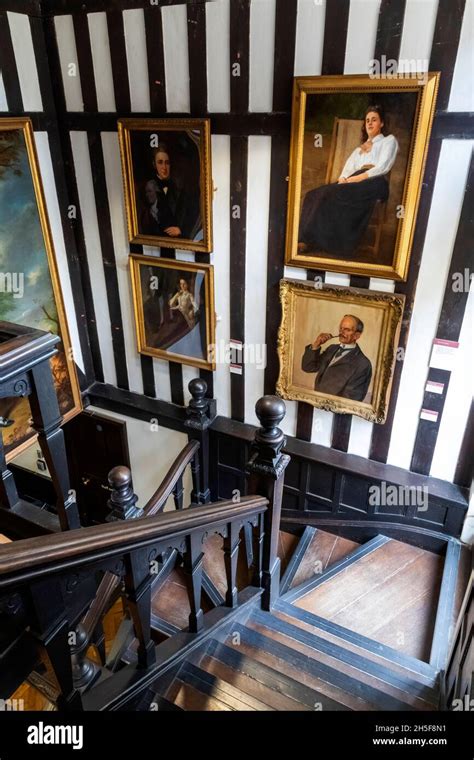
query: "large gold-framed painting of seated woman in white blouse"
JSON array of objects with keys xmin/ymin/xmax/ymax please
[{"xmin": 286, "ymin": 72, "xmax": 439, "ymax": 280}]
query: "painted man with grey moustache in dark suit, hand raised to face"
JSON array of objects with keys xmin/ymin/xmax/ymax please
[{"xmin": 301, "ymin": 314, "xmax": 372, "ymax": 401}]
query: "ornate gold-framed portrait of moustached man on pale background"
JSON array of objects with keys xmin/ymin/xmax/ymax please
[{"xmin": 277, "ymin": 280, "xmax": 405, "ymax": 423}]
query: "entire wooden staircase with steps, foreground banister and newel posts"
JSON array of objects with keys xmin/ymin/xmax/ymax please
[{"xmin": 0, "ymin": 388, "xmax": 472, "ymax": 712}]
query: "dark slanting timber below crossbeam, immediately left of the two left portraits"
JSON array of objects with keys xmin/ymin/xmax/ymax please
[{"xmin": 88, "ymin": 134, "xmax": 129, "ymax": 390}]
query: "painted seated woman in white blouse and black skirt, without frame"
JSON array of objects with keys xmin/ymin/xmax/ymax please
[{"xmin": 298, "ymin": 104, "xmax": 399, "ymax": 258}]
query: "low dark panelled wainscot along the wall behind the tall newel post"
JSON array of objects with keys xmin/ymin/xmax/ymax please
[{"xmin": 210, "ymin": 417, "xmax": 469, "ymax": 551}]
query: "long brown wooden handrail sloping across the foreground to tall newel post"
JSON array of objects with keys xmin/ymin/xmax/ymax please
[{"xmin": 0, "ymin": 496, "xmax": 268, "ymax": 589}]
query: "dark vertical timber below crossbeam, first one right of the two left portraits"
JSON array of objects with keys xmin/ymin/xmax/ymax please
[{"xmin": 229, "ymin": 136, "xmax": 248, "ymax": 421}]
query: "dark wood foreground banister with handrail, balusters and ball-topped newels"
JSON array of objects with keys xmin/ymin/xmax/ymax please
[{"xmin": 0, "ymin": 388, "xmax": 289, "ymax": 709}]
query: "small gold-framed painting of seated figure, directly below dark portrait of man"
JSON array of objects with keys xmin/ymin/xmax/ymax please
[{"xmin": 130, "ymin": 254, "xmax": 215, "ymax": 370}]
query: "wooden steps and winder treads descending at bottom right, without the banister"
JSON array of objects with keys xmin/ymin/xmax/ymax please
[{"xmin": 144, "ymin": 527, "xmax": 470, "ymax": 711}]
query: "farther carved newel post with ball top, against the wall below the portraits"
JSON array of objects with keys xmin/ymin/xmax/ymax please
[{"xmin": 184, "ymin": 378, "xmax": 215, "ymax": 504}]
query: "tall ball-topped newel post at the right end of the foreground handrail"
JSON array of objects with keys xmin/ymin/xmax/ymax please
[{"xmin": 245, "ymin": 396, "xmax": 290, "ymax": 610}]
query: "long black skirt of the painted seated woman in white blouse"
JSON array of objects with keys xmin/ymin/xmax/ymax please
[{"xmin": 298, "ymin": 172, "xmax": 388, "ymax": 257}]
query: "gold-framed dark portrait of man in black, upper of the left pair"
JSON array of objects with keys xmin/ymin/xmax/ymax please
[{"xmin": 118, "ymin": 119, "xmax": 212, "ymax": 253}]
